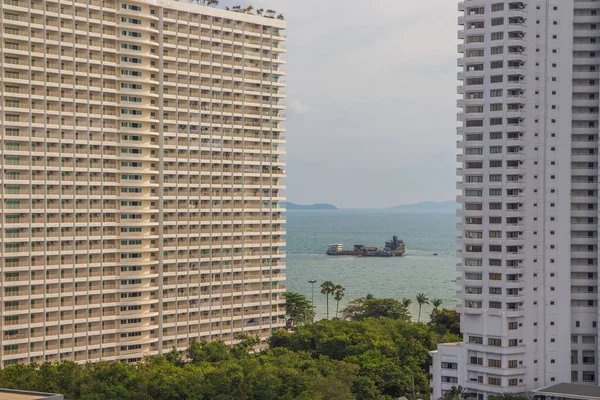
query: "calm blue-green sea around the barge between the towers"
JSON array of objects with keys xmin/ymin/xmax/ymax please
[{"xmin": 287, "ymin": 210, "xmax": 457, "ymax": 318}]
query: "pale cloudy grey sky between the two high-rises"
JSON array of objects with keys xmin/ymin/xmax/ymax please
[{"xmin": 219, "ymin": 0, "xmax": 458, "ymax": 208}]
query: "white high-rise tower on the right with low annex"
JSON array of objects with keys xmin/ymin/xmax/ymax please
[{"xmin": 433, "ymin": 0, "xmax": 600, "ymax": 400}]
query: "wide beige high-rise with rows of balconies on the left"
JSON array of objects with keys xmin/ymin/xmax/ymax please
[{"xmin": 0, "ymin": 0, "xmax": 285, "ymax": 365}]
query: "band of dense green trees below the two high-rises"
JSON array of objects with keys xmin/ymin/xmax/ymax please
[{"xmin": 0, "ymin": 295, "xmax": 458, "ymax": 400}]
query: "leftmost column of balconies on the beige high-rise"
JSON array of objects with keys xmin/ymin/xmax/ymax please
[{"xmin": 0, "ymin": 3, "xmax": 34, "ymax": 365}]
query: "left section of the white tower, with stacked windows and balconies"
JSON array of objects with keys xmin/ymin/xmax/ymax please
[{"xmin": 458, "ymin": 0, "xmax": 527, "ymax": 393}]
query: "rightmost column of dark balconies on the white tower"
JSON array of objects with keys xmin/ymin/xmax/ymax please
[{"xmin": 570, "ymin": 1, "xmax": 600, "ymax": 384}]
